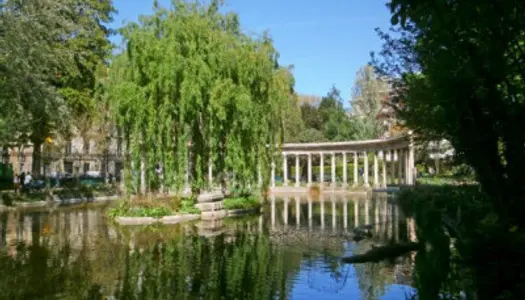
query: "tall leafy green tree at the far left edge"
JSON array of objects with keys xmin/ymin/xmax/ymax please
[{"xmin": 0, "ymin": 0, "xmax": 112, "ymax": 172}]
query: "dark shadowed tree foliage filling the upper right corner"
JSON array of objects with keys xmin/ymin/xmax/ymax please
[{"xmin": 376, "ymin": 0, "xmax": 525, "ymax": 227}]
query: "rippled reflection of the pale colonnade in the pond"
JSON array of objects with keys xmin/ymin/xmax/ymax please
[{"xmin": 269, "ymin": 194, "xmax": 415, "ymax": 241}]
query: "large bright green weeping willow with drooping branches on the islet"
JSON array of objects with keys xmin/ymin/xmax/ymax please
[{"xmin": 108, "ymin": 1, "xmax": 293, "ymax": 193}]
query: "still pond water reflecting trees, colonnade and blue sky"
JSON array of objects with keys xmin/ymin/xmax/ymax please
[{"xmin": 0, "ymin": 195, "xmax": 414, "ymax": 299}]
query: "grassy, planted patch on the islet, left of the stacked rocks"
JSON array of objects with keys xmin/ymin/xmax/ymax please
[{"xmin": 107, "ymin": 197, "xmax": 200, "ymax": 219}]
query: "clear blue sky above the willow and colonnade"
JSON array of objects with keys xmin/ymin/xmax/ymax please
[{"xmin": 108, "ymin": 0, "xmax": 390, "ymax": 106}]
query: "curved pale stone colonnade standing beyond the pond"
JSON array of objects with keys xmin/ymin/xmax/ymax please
[{"xmin": 270, "ymin": 133, "xmax": 415, "ymax": 187}]
